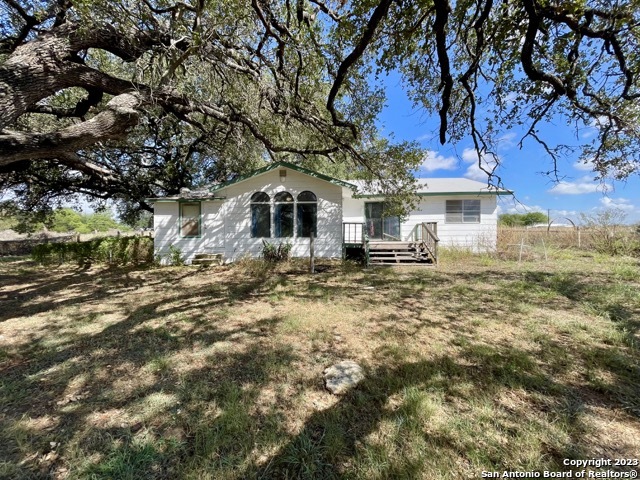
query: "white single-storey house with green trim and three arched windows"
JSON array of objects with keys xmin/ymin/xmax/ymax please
[{"xmin": 149, "ymin": 162, "xmax": 511, "ymax": 263}]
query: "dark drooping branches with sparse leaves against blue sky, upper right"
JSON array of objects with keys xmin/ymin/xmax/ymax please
[{"xmin": 334, "ymin": 0, "xmax": 640, "ymax": 179}]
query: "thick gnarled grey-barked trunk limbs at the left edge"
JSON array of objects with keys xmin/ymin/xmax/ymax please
[{"xmin": 0, "ymin": 24, "xmax": 158, "ymax": 166}]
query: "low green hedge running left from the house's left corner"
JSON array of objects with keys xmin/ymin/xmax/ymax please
[{"xmin": 31, "ymin": 237, "xmax": 154, "ymax": 265}]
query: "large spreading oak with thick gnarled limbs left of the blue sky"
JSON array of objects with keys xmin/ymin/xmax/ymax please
[{"xmin": 0, "ymin": 0, "xmax": 419, "ymax": 222}]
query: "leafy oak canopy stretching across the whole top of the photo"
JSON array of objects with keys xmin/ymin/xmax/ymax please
[{"xmin": 0, "ymin": 0, "xmax": 640, "ymax": 221}]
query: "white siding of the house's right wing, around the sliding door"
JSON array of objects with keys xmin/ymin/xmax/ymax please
[{"xmin": 344, "ymin": 195, "xmax": 498, "ymax": 252}]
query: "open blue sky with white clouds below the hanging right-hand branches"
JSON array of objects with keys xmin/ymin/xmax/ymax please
[{"xmin": 379, "ymin": 75, "xmax": 640, "ymax": 223}]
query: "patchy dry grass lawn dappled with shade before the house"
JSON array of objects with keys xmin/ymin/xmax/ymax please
[{"xmin": 0, "ymin": 250, "xmax": 640, "ymax": 479}]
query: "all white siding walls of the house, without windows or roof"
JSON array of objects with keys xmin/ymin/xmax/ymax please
[{"xmin": 154, "ymin": 168, "xmax": 497, "ymax": 263}]
